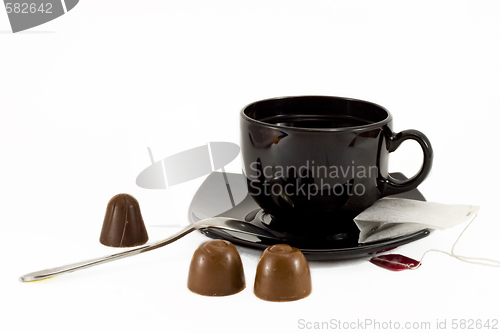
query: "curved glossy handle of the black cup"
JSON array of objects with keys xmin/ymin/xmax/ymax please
[{"xmin": 382, "ymin": 130, "xmax": 433, "ymax": 196}]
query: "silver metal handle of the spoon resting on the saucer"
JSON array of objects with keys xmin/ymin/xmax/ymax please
[{"xmin": 19, "ymin": 221, "xmax": 197, "ymax": 282}]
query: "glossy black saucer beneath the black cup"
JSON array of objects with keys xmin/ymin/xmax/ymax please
[{"xmin": 189, "ymin": 172, "xmax": 430, "ymax": 260}]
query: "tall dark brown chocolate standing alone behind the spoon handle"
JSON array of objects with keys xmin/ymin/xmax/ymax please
[{"xmin": 99, "ymin": 194, "xmax": 149, "ymax": 247}]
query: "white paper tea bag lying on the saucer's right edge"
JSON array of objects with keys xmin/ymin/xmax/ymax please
[{"xmin": 354, "ymin": 197, "xmax": 479, "ymax": 243}]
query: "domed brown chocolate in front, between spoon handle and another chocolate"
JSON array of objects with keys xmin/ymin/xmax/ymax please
[{"xmin": 188, "ymin": 239, "xmax": 245, "ymax": 296}]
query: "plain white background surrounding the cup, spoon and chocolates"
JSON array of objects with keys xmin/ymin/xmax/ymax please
[{"xmin": 0, "ymin": 0, "xmax": 500, "ymax": 332}]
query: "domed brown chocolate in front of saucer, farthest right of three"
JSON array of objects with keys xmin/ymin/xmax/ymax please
[{"xmin": 254, "ymin": 244, "xmax": 312, "ymax": 302}]
